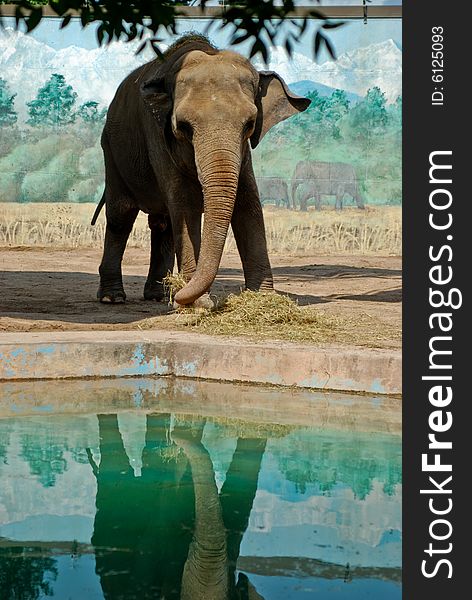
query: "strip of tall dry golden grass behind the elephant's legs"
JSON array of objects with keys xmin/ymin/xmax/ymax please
[{"xmin": 0, "ymin": 203, "xmax": 402, "ymax": 256}]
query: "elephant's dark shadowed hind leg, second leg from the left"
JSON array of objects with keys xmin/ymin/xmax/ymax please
[{"xmin": 144, "ymin": 215, "xmax": 175, "ymax": 302}]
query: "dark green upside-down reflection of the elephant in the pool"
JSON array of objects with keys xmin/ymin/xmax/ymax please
[{"xmin": 89, "ymin": 415, "xmax": 266, "ymax": 600}]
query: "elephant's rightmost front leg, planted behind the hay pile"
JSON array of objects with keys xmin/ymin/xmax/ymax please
[{"xmin": 231, "ymin": 171, "xmax": 274, "ymax": 291}]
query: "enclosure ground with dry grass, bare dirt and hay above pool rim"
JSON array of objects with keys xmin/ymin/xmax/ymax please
[{"xmin": 0, "ymin": 203, "xmax": 402, "ymax": 348}]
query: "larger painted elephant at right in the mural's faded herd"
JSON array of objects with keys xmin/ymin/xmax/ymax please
[{"xmin": 292, "ymin": 160, "xmax": 364, "ymax": 211}]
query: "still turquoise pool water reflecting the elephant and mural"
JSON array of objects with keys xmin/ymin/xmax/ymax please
[{"xmin": 0, "ymin": 379, "xmax": 401, "ymax": 600}]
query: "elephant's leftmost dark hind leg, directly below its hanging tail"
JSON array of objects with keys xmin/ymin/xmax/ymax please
[{"xmin": 97, "ymin": 208, "xmax": 139, "ymax": 304}]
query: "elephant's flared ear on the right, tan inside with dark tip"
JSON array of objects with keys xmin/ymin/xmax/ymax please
[{"xmin": 251, "ymin": 71, "xmax": 311, "ymax": 148}]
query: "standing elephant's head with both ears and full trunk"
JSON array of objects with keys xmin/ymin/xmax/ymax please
[{"xmin": 141, "ymin": 41, "xmax": 310, "ymax": 304}]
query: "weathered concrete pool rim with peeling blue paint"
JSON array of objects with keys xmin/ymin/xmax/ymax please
[{"xmin": 0, "ymin": 330, "xmax": 401, "ymax": 394}]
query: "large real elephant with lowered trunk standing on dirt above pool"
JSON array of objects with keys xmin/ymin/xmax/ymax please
[{"xmin": 92, "ymin": 34, "xmax": 310, "ymax": 305}]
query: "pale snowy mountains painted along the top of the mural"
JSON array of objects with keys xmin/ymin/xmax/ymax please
[{"xmin": 0, "ymin": 29, "xmax": 402, "ymax": 121}]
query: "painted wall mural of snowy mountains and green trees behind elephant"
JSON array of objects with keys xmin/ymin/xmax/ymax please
[{"xmin": 0, "ymin": 19, "xmax": 402, "ymax": 209}]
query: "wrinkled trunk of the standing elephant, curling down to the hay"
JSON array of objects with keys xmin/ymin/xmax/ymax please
[{"xmin": 175, "ymin": 132, "xmax": 241, "ymax": 304}]
